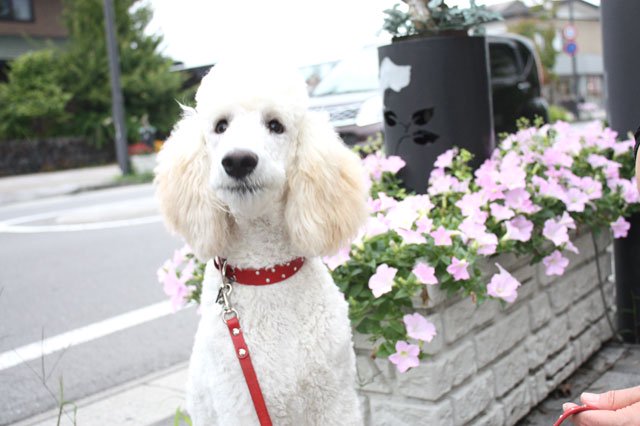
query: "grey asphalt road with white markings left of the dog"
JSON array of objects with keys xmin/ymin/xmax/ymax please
[{"xmin": 0, "ymin": 185, "xmax": 198, "ymax": 425}]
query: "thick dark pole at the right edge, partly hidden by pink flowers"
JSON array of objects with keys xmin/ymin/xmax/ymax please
[{"xmin": 600, "ymin": 0, "xmax": 640, "ymax": 343}]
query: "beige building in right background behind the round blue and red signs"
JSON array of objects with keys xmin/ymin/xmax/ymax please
[{"xmin": 487, "ymin": 0, "xmax": 604, "ymax": 109}]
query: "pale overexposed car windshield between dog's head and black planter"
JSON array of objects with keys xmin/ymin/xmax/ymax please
[{"xmin": 311, "ymin": 48, "xmax": 378, "ymax": 96}]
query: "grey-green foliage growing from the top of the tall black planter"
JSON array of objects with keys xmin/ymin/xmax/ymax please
[{"xmin": 383, "ymin": 0, "xmax": 502, "ymax": 37}]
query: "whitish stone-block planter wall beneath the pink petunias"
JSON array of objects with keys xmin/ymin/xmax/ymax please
[{"xmin": 354, "ymin": 234, "xmax": 614, "ymax": 426}]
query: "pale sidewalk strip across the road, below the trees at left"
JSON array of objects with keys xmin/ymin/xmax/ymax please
[{"xmin": 0, "ymin": 164, "xmax": 121, "ymax": 206}]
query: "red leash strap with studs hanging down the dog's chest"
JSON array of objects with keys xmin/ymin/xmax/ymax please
[{"xmin": 225, "ymin": 315, "xmax": 272, "ymax": 426}]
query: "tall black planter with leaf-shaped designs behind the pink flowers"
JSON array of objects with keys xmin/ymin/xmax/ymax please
[{"xmin": 378, "ymin": 36, "xmax": 494, "ymax": 193}]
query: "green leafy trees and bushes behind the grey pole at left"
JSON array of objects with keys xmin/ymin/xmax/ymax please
[{"xmin": 0, "ymin": 0, "xmax": 183, "ymax": 145}]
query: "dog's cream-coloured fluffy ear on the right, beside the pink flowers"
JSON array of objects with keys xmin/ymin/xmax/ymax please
[{"xmin": 285, "ymin": 112, "xmax": 367, "ymax": 255}]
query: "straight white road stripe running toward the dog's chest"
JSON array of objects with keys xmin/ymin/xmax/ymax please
[{"xmin": 0, "ymin": 300, "xmax": 185, "ymax": 371}]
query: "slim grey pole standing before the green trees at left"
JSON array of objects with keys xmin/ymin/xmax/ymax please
[{"xmin": 104, "ymin": 0, "xmax": 129, "ymax": 175}]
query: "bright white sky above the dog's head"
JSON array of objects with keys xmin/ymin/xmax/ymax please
[{"xmin": 144, "ymin": 0, "xmax": 599, "ymax": 66}]
